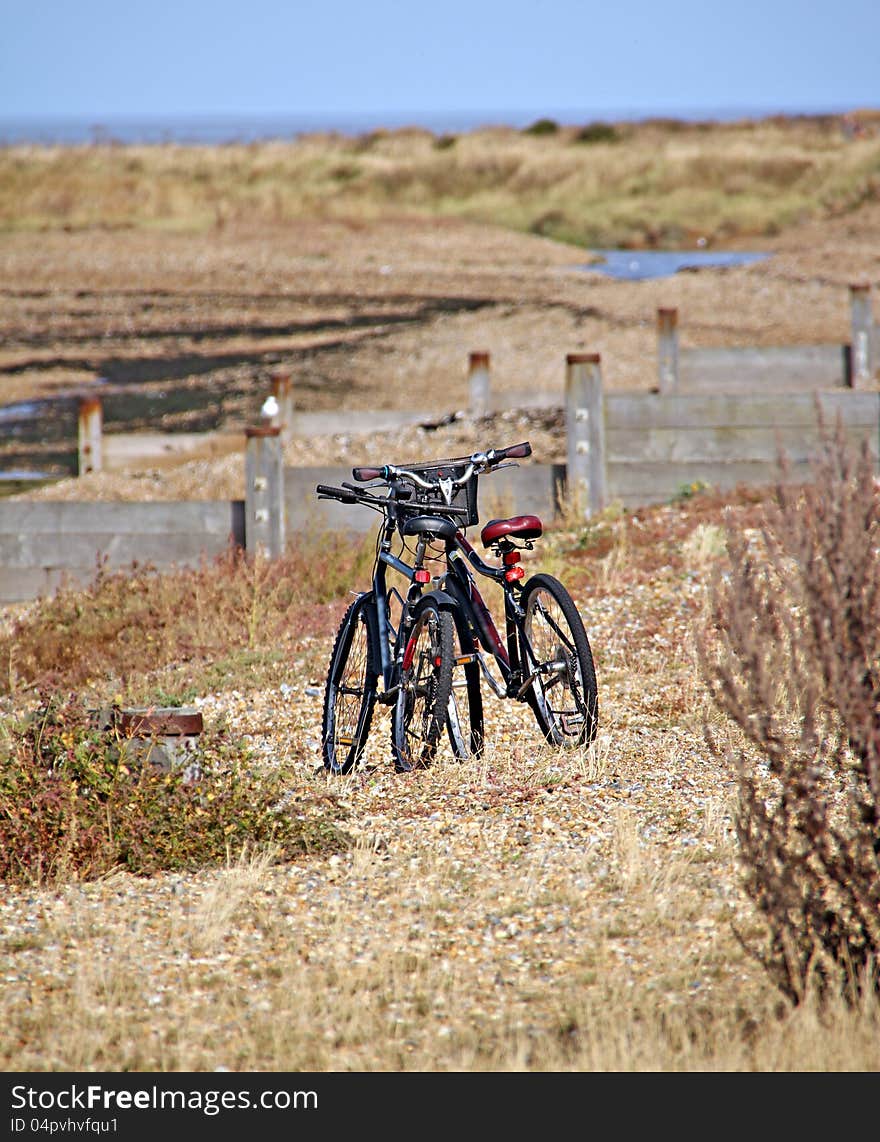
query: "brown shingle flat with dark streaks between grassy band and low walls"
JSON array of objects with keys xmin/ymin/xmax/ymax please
[{"xmin": 0, "ymin": 204, "xmax": 880, "ymax": 498}]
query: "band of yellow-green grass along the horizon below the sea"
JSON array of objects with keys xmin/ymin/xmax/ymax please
[{"xmin": 0, "ymin": 112, "xmax": 880, "ymax": 249}]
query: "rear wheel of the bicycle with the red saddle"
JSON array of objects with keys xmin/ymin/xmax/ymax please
[{"xmin": 518, "ymin": 573, "xmax": 599, "ymax": 748}]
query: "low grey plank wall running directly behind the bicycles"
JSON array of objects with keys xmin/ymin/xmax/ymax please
[{"xmin": 0, "ymin": 388, "xmax": 880, "ymax": 604}]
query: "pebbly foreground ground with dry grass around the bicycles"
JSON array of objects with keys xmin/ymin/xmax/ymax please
[{"xmin": 0, "ymin": 484, "xmax": 878, "ymax": 1072}]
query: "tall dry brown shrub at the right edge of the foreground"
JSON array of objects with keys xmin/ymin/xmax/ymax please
[{"xmin": 700, "ymin": 421, "xmax": 880, "ymax": 1004}]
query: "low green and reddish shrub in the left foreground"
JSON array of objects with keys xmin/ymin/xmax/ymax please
[{"xmin": 0, "ymin": 694, "xmax": 349, "ymax": 885}]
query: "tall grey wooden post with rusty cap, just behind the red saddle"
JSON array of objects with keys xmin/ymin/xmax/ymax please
[{"xmin": 565, "ymin": 353, "xmax": 607, "ymax": 517}]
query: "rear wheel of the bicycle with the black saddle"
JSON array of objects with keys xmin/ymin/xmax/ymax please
[{"xmin": 391, "ymin": 595, "xmax": 454, "ymax": 773}]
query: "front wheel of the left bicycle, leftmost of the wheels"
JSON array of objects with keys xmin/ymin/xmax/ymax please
[{"xmin": 321, "ymin": 592, "xmax": 379, "ymax": 774}]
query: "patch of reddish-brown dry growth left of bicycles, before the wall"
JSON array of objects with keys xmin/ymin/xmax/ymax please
[{"xmin": 0, "ymin": 532, "xmax": 372, "ymax": 693}]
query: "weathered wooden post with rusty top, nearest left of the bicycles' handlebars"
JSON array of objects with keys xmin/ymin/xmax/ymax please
[{"xmin": 244, "ymin": 425, "xmax": 284, "ymax": 560}]
